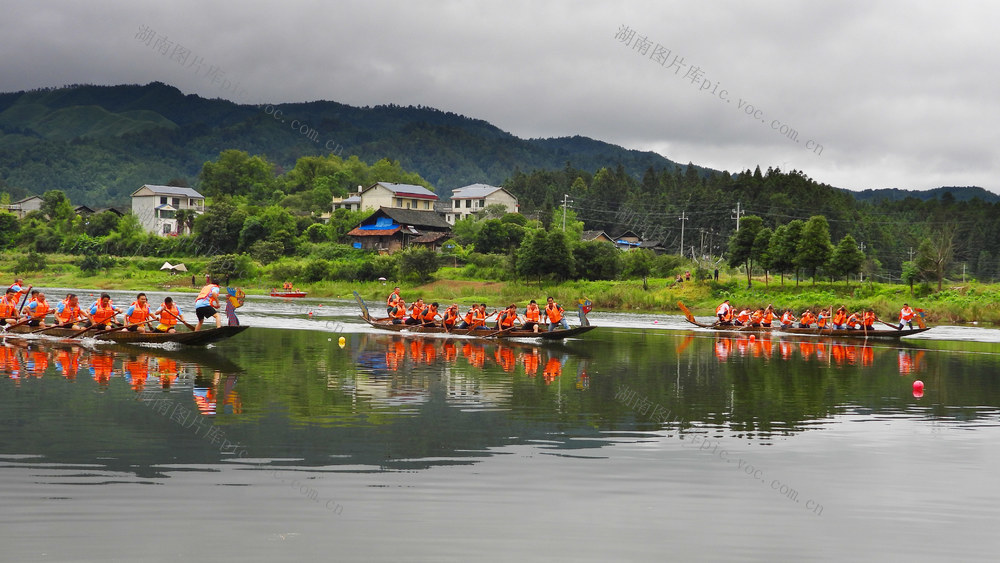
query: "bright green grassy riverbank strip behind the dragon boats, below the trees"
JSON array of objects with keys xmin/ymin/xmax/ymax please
[{"xmin": 0, "ymin": 253, "xmax": 1000, "ymax": 325}]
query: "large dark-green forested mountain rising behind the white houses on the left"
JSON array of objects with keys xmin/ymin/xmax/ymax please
[{"xmin": 0, "ymin": 82, "xmax": 696, "ymax": 207}]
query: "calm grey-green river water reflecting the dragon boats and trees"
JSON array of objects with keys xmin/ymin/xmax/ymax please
[{"xmin": 0, "ymin": 291, "xmax": 1000, "ymax": 561}]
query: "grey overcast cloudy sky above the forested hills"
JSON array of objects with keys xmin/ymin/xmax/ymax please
[{"xmin": 0, "ymin": 0, "xmax": 1000, "ymax": 192}]
